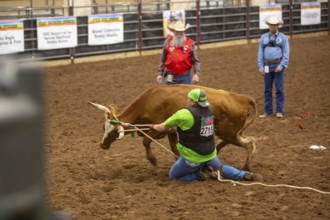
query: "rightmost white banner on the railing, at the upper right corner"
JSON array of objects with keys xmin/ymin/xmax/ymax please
[{"xmin": 301, "ymin": 2, "xmax": 321, "ymax": 25}]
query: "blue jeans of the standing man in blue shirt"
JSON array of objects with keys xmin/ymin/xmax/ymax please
[{"xmin": 264, "ymin": 64, "xmax": 284, "ymax": 114}]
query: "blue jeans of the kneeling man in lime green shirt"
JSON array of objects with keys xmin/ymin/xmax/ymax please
[{"xmin": 169, "ymin": 156, "xmax": 246, "ymax": 181}]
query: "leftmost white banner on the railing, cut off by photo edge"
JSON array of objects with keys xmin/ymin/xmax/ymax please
[{"xmin": 0, "ymin": 20, "xmax": 24, "ymax": 54}]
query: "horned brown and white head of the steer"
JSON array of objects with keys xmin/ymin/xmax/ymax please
[{"xmin": 88, "ymin": 102, "xmax": 124, "ymax": 149}]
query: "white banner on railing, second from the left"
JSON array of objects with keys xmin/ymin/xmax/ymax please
[{"xmin": 37, "ymin": 16, "xmax": 78, "ymax": 50}]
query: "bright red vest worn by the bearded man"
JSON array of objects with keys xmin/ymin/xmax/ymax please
[{"xmin": 165, "ymin": 37, "xmax": 194, "ymax": 75}]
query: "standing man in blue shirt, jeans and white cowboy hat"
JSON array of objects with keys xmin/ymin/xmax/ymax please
[{"xmin": 258, "ymin": 16, "xmax": 290, "ymax": 118}]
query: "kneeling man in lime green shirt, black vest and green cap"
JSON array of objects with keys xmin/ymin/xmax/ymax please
[{"xmin": 151, "ymin": 89, "xmax": 263, "ymax": 181}]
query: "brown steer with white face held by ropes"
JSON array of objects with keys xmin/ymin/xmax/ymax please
[{"xmin": 89, "ymin": 85, "xmax": 257, "ymax": 170}]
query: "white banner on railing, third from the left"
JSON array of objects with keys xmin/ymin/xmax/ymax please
[{"xmin": 88, "ymin": 14, "xmax": 124, "ymax": 45}]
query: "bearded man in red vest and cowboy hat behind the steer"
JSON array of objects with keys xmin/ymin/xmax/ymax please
[{"xmin": 157, "ymin": 21, "xmax": 200, "ymax": 84}]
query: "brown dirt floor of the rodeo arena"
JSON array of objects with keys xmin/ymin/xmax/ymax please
[{"xmin": 44, "ymin": 36, "xmax": 330, "ymax": 220}]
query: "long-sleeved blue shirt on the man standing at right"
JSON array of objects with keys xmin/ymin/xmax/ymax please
[{"xmin": 258, "ymin": 31, "xmax": 290, "ymax": 71}]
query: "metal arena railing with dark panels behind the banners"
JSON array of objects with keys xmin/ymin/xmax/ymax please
[{"xmin": 0, "ymin": 0, "xmax": 330, "ymax": 61}]
